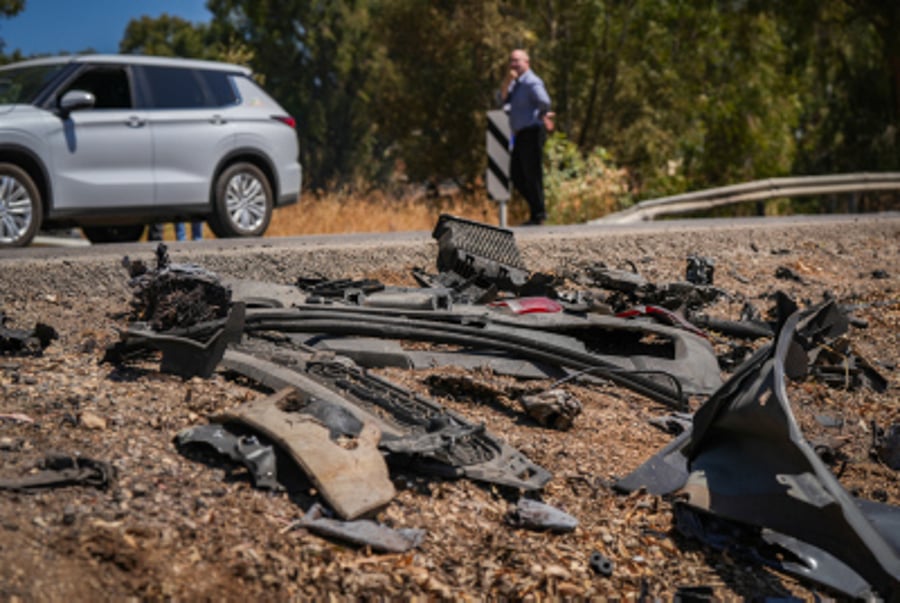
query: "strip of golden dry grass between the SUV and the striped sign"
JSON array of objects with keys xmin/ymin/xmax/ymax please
[{"xmin": 266, "ymin": 191, "xmax": 527, "ymax": 237}]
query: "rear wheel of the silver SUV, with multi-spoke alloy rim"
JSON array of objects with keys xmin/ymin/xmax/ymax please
[{"xmin": 209, "ymin": 162, "xmax": 275, "ymax": 238}]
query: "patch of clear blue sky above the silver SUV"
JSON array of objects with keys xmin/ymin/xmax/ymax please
[{"xmin": 0, "ymin": 0, "xmax": 212, "ymax": 56}]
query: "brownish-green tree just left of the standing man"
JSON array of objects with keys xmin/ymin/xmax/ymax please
[{"xmin": 373, "ymin": 0, "xmax": 520, "ymax": 183}]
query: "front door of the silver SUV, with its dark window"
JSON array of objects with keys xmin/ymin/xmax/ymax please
[{"xmin": 47, "ymin": 64, "xmax": 154, "ymax": 211}]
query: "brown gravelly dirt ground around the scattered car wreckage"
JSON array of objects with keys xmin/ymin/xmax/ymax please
[{"xmin": 0, "ymin": 215, "xmax": 900, "ymax": 601}]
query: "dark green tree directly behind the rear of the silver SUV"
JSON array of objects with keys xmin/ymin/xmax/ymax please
[{"xmin": 208, "ymin": 0, "xmax": 383, "ymax": 187}]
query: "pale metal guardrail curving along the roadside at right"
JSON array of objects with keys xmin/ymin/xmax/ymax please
[{"xmin": 590, "ymin": 172, "xmax": 900, "ymax": 224}]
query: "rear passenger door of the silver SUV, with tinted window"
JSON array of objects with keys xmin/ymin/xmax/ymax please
[{"xmin": 138, "ymin": 65, "xmax": 235, "ymax": 211}]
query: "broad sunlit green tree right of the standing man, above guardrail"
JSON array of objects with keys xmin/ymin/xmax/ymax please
[{"xmin": 511, "ymin": 0, "xmax": 799, "ymax": 196}]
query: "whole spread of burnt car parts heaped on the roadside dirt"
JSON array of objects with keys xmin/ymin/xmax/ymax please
[{"xmin": 77, "ymin": 216, "xmax": 900, "ymax": 600}]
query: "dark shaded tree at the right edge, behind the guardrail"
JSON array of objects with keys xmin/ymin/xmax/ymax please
[{"xmin": 768, "ymin": 0, "xmax": 900, "ymax": 173}]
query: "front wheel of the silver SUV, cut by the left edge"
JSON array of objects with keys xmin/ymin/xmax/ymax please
[{"xmin": 0, "ymin": 163, "xmax": 44, "ymax": 247}]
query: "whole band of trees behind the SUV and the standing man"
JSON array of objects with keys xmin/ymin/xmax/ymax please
[{"xmin": 110, "ymin": 0, "xmax": 900, "ymax": 197}]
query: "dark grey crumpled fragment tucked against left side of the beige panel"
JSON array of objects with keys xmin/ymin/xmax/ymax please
[{"xmin": 175, "ymin": 423, "xmax": 283, "ymax": 490}]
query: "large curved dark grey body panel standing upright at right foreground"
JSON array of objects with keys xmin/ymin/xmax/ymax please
[{"xmin": 684, "ymin": 312, "xmax": 900, "ymax": 599}]
